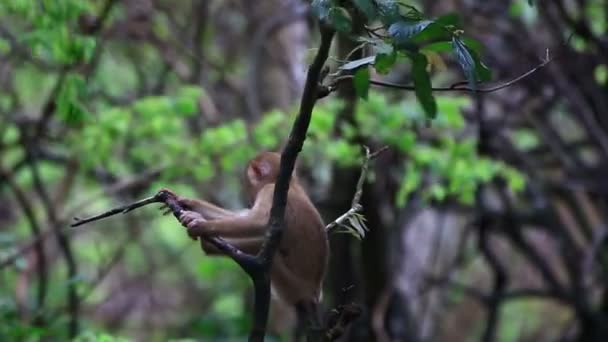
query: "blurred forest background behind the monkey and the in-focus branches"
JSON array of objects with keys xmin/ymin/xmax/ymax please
[{"xmin": 0, "ymin": 0, "xmax": 608, "ymax": 341}]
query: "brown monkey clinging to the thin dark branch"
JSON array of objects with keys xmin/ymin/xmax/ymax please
[{"xmin": 166, "ymin": 152, "xmax": 329, "ymax": 310}]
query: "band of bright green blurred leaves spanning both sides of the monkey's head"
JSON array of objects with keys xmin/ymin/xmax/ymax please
[{"xmin": 81, "ymin": 91, "xmax": 524, "ymax": 206}]
